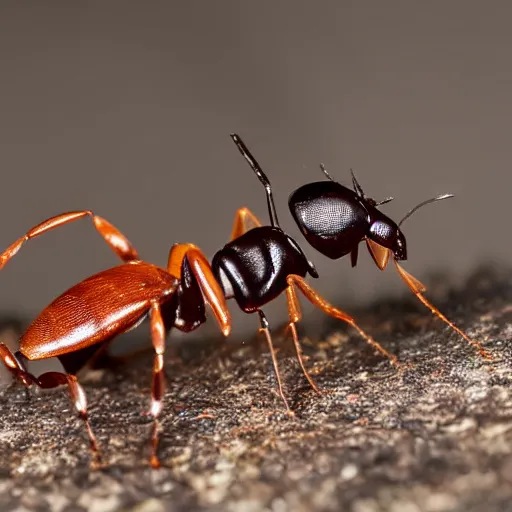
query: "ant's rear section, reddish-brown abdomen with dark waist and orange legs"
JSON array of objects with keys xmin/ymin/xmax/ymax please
[{"xmin": 0, "ymin": 210, "xmax": 231, "ymax": 468}]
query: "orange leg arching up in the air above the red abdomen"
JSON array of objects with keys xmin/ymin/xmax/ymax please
[{"xmin": 0, "ymin": 210, "xmax": 139, "ymax": 269}]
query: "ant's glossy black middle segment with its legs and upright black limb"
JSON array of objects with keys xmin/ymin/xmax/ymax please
[{"xmin": 212, "ymin": 134, "xmax": 398, "ymax": 414}]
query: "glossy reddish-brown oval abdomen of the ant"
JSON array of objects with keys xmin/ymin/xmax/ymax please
[{"xmin": 20, "ymin": 261, "xmax": 178, "ymax": 360}]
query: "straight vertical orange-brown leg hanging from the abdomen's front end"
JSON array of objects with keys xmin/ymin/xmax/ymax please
[{"xmin": 150, "ymin": 302, "xmax": 165, "ymax": 469}]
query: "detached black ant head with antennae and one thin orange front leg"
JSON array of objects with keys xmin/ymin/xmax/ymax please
[{"xmin": 288, "ymin": 164, "xmax": 492, "ymax": 359}]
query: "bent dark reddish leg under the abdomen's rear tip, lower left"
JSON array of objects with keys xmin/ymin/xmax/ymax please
[{"xmin": 0, "ymin": 343, "xmax": 100, "ymax": 462}]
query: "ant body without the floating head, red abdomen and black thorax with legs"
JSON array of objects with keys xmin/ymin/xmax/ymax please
[{"xmin": 0, "ymin": 134, "xmax": 398, "ymax": 468}]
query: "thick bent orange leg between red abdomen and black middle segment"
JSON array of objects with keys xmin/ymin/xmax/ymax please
[{"xmin": 167, "ymin": 244, "xmax": 231, "ymax": 336}]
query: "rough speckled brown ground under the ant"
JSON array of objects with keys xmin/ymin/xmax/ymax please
[{"xmin": 0, "ymin": 269, "xmax": 512, "ymax": 512}]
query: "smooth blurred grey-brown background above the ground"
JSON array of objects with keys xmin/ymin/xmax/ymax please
[{"xmin": 0, "ymin": 0, "xmax": 512, "ymax": 340}]
